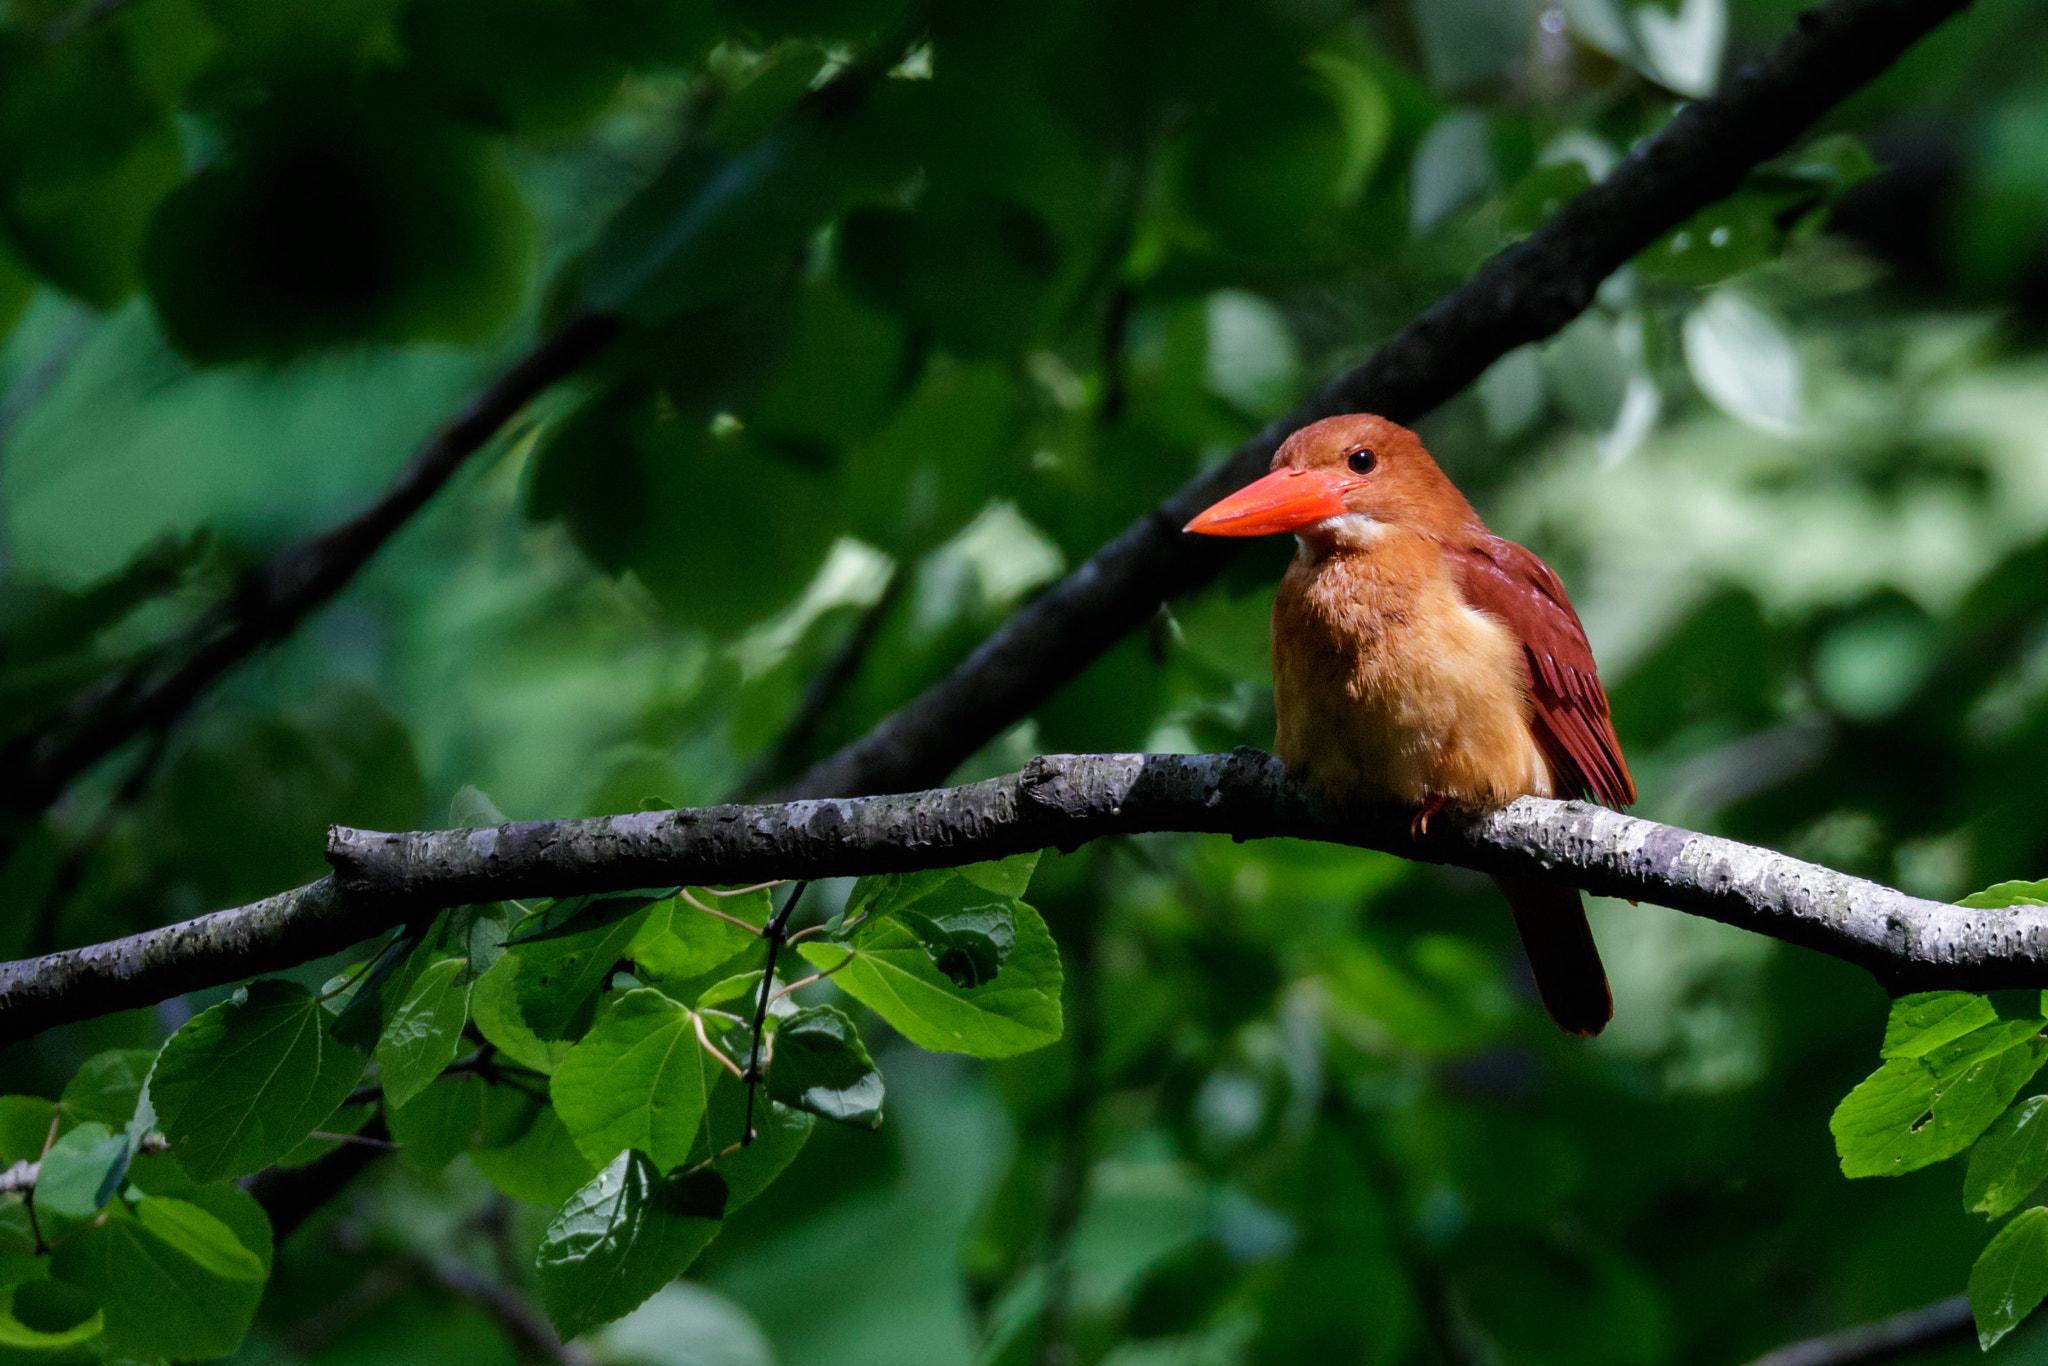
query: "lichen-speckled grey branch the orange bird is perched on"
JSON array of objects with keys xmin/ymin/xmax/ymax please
[{"xmin": 0, "ymin": 750, "xmax": 2048, "ymax": 1040}]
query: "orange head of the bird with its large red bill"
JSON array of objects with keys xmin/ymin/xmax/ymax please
[{"xmin": 1186, "ymin": 414, "xmax": 1477, "ymax": 551}]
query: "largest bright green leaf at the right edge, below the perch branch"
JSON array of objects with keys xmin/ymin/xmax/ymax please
[{"xmin": 1829, "ymin": 1020, "xmax": 2048, "ymax": 1176}]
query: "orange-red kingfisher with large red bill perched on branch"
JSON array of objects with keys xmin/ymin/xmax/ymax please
[{"xmin": 1186, "ymin": 414, "xmax": 1636, "ymax": 1036}]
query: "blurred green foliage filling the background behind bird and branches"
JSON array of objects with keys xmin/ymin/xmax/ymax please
[{"xmin": 0, "ymin": 0, "xmax": 2048, "ymax": 1366}]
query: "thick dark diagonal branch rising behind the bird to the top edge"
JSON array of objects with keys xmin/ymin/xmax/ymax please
[{"xmin": 782, "ymin": 0, "xmax": 1968, "ymax": 797}]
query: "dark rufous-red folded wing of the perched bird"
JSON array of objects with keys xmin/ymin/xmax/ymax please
[{"xmin": 1446, "ymin": 535, "xmax": 1636, "ymax": 807}]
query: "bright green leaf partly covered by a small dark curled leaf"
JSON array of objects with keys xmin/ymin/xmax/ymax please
[{"xmin": 799, "ymin": 901, "xmax": 1064, "ymax": 1056}]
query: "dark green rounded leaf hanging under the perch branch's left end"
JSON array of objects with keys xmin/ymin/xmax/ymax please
[{"xmin": 150, "ymin": 981, "xmax": 362, "ymax": 1182}]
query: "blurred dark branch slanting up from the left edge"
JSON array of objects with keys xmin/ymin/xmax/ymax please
[{"xmin": 0, "ymin": 313, "xmax": 618, "ymax": 823}]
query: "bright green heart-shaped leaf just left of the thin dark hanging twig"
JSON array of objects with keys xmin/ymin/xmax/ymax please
[{"xmin": 551, "ymin": 987, "xmax": 725, "ymax": 1171}]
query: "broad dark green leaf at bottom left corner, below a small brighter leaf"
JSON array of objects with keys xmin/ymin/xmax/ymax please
[{"xmin": 49, "ymin": 1202, "xmax": 264, "ymax": 1360}]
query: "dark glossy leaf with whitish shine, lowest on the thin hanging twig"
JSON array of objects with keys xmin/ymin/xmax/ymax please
[{"xmin": 537, "ymin": 1151, "xmax": 725, "ymax": 1339}]
